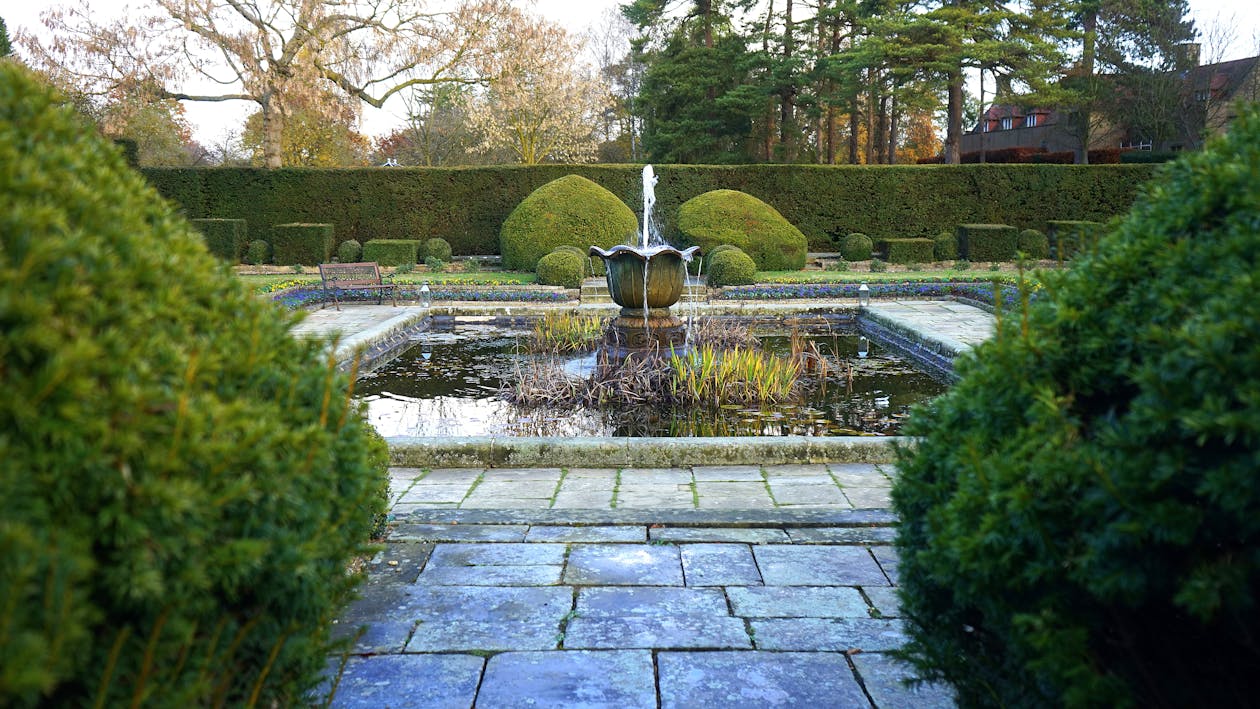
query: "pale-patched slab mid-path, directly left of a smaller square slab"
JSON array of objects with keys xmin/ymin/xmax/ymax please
[{"xmin": 564, "ymin": 544, "xmax": 683, "ymax": 586}]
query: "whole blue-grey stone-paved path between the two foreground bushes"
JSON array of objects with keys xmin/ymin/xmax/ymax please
[{"xmin": 317, "ymin": 465, "xmax": 953, "ymax": 709}]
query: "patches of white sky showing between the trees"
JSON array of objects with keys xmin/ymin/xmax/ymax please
[{"xmin": 0, "ymin": 0, "xmax": 1260, "ymax": 141}]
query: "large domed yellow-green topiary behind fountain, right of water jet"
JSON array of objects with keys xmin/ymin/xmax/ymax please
[{"xmin": 678, "ymin": 190, "xmax": 808, "ymax": 271}]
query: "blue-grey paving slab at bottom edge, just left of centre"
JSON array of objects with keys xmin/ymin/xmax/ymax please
[{"xmin": 476, "ymin": 650, "xmax": 656, "ymax": 709}]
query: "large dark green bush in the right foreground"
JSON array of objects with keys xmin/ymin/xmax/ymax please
[{"xmin": 893, "ymin": 110, "xmax": 1260, "ymax": 706}]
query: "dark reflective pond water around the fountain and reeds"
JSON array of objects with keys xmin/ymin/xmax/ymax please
[{"xmin": 355, "ymin": 321, "xmax": 948, "ymax": 436}]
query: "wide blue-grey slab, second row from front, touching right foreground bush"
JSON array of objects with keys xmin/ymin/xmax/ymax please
[{"xmin": 748, "ymin": 618, "xmax": 906, "ymax": 652}]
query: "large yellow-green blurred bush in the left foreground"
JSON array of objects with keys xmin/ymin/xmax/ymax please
[{"xmin": 0, "ymin": 62, "xmax": 387, "ymax": 706}]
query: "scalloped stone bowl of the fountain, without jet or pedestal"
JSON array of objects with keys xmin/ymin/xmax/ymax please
[{"xmin": 588, "ymin": 244, "xmax": 699, "ymax": 311}]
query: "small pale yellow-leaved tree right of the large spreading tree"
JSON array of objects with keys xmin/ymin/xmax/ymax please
[{"xmin": 469, "ymin": 10, "xmax": 610, "ymax": 165}]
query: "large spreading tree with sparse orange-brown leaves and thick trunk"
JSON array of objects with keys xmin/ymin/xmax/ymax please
[{"xmin": 19, "ymin": 0, "xmax": 508, "ymax": 167}]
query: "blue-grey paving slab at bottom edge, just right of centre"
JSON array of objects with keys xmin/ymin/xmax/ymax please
[{"xmin": 656, "ymin": 652, "xmax": 869, "ymax": 709}]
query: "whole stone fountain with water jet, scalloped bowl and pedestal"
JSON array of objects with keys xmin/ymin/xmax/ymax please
[{"xmin": 590, "ymin": 165, "xmax": 699, "ymax": 361}]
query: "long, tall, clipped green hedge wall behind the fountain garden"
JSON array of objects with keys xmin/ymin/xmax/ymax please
[{"xmin": 142, "ymin": 165, "xmax": 1155, "ymax": 254}]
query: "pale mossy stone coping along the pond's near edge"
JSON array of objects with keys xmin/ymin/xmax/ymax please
[{"xmin": 387, "ymin": 436, "xmax": 910, "ymax": 467}]
